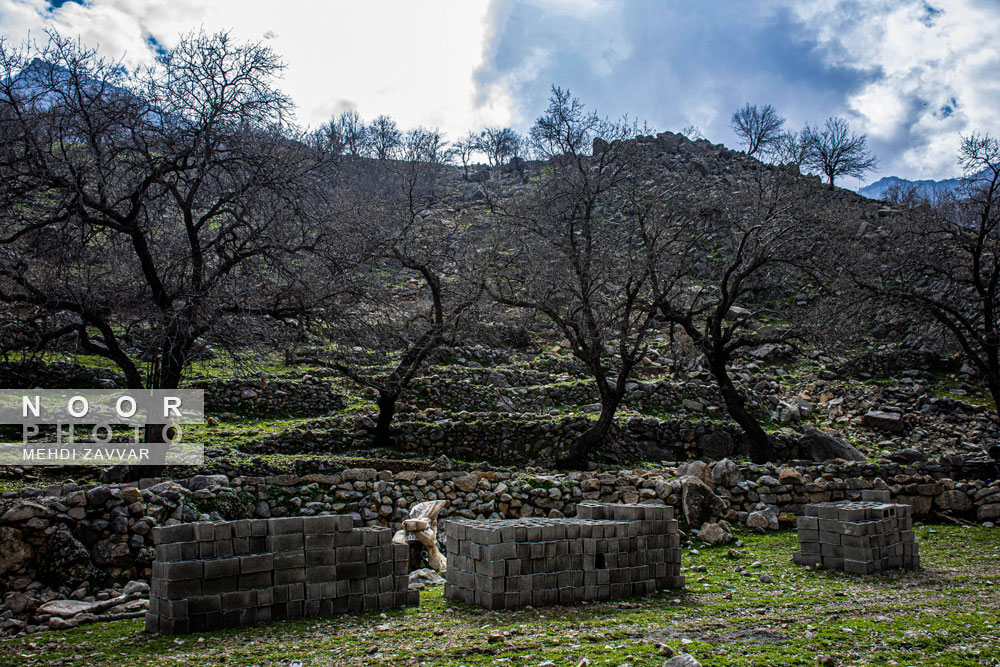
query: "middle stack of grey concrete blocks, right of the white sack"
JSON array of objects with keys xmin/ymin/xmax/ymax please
[{"xmin": 444, "ymin": 503, "xmax": 684, "ymax": 609}]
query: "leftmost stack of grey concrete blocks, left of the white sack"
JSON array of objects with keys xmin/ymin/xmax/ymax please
[{"xmin": 146, "ymin": 516, "xmax": 419, "ymax": 634}]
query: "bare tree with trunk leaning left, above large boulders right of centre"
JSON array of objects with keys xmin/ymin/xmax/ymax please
[{"xmin": 650, "ymin": 164, "xmax": 822, "ymax": 463}]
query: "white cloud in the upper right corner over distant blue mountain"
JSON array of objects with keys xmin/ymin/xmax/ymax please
[{"xmin": 794, "ymin": 0, "xmax": 1000, "ymax": 178}]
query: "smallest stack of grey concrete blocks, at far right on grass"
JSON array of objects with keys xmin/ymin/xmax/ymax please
[{"xmin": 792, "ymin": 492, "xmax": 920, "ymax": 574}]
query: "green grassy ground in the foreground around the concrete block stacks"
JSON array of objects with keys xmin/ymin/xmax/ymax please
[{"xmin": 0, "ymin": 527, "xmax": 1000, "ymax": 667}]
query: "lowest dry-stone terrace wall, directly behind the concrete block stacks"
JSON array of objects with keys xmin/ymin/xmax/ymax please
[{"xmin": 0, "ymin": 461, "xmax": 1000, "ymax": 592}]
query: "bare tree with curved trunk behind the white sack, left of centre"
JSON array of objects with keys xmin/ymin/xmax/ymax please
[{"xmin": 317, "ymin": 129, "xmax": 487, "ymax": 446}]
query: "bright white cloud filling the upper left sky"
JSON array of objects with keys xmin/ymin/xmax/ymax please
[{"xmin": 0, "ymin": 0, "xmax": 500, "ymax": 136}]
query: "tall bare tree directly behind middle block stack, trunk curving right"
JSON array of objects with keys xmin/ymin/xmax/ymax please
[{"xmin": 492, "ymin": 87, "xmax": 662, "ymax": 467}]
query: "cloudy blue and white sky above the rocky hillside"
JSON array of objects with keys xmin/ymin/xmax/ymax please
[{"xmin": 0, "ymin": 0, "xmax": 1000, "ymax": 187}]
